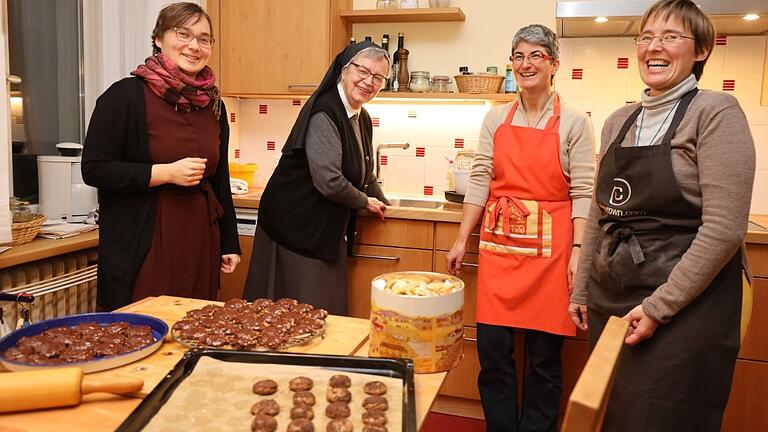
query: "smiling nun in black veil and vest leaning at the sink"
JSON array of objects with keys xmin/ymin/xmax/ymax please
[{"xmin": 245, "ymin": 42, "xmax": 390, "ymax": 315}]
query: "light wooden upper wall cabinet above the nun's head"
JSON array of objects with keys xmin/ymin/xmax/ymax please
[{"xmin": 208, "ymin": 0, "xmax": 352, "ymax": 95}]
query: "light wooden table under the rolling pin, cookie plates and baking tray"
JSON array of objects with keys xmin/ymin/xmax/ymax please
[{"xmin": 0, "ymin": 296, "xmax": 446, "ymax": 432}]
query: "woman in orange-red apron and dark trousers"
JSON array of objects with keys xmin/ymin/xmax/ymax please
[{"xmin": 447, "ymin": 25, "xmax": 594, "ymax": 431}]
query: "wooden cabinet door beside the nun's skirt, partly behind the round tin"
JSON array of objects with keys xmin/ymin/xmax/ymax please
[{"xmin": 347, "ymin": 245, "xmax": 432, "ymax": 319}]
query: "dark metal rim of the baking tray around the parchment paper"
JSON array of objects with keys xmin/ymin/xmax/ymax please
[{"xmin": 116, "ymin": 348, "xmax": 417, "ymax": 432}]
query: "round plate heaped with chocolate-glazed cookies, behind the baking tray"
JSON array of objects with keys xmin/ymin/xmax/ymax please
[{"xmin": 171, "ymin": 298, "xmax": 328, "ymax": 351}]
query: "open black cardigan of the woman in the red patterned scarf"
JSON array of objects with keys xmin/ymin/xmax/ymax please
[{"xmin": 82, "ymin": 77, "xmax": 240, "ymax": 309}]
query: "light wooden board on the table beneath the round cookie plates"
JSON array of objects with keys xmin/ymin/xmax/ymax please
[{"xmin": 92, "ymin": 296, "xmax": 369, "ymax": 398}]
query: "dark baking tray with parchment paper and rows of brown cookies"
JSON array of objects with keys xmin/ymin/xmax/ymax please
[{"xmin": 117, "ymin": 349, "xmax": 416, "ymax": 432}]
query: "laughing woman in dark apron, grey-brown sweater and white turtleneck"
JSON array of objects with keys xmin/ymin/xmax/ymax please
[{"xmin": 569, "ymin": 0, "xmax": 755, "ymax": 431}]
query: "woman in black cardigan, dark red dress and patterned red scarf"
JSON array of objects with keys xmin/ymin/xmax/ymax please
[{"xmin": 82, "ymin": 3, "xmax": 240, "ymax": 310}]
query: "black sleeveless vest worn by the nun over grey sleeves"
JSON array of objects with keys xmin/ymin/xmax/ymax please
[{"xmin": 258, "ymin": 87, "xmax": 379, "ymax": 258}]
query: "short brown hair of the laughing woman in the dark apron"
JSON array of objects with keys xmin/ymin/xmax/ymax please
[{"xmin": 640, "ymin": 0, "xmax": 715, "ymax": 80}]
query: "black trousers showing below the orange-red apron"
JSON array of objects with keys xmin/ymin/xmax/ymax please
[{"xmin": 477, "ymin": 323, "xmax": 563, "ymax": 432}]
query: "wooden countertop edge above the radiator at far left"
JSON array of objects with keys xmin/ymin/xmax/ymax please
[{"xmin": 0, "ymin": 230, "xmax": 99, "ymax": 269}]
